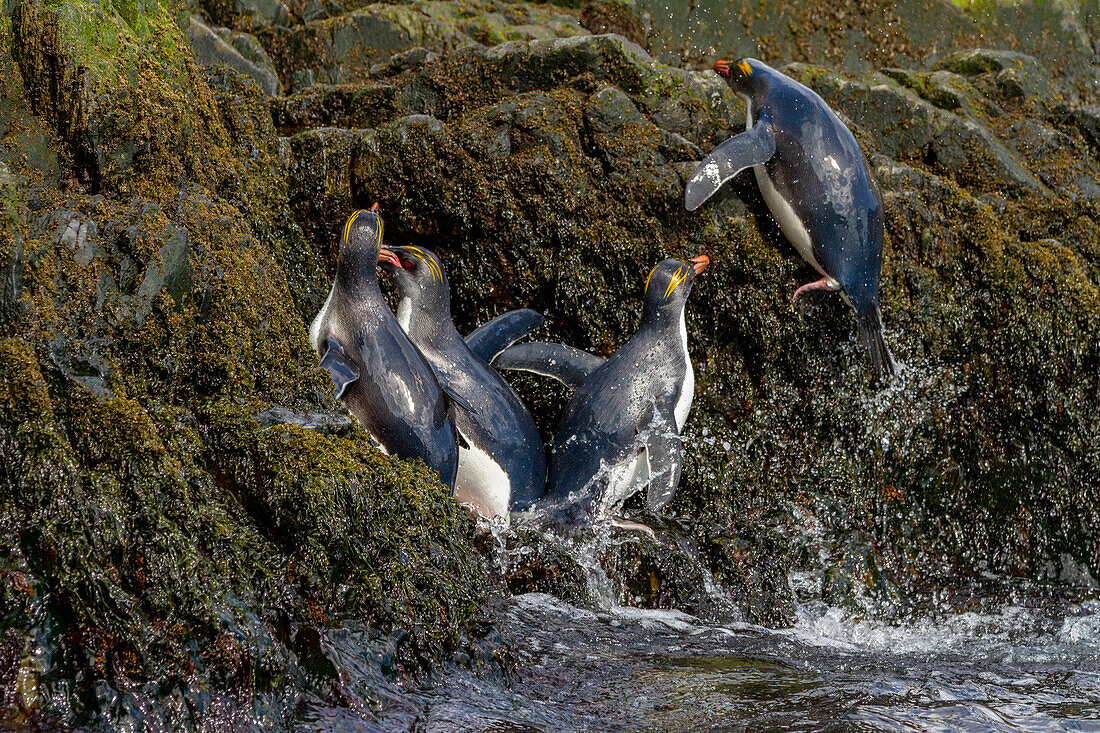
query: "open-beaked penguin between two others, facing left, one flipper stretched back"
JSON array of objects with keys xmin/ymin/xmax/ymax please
[{"xmin": 383, "ymin": 247, "xmax": 547, "ymax": 512}]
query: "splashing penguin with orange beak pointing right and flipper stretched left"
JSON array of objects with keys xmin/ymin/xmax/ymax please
[{"xmin": 493, "ymin": 254, "xmax": 710, "ymax": 521}]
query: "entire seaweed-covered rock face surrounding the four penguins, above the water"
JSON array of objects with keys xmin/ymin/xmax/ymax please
[{"xmin": 0, "ymin": 0, "xmax": 1100, "ymax": 726}]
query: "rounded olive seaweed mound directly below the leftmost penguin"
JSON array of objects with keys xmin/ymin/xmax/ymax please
[{"xmin": 203, "ymin": 404, "xmax": 484, "ymax": 664}]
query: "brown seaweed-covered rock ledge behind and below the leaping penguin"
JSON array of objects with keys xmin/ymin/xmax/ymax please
[{"xmin": 281, "ymin": 28, "xmax": 1100, "ymax": 608}]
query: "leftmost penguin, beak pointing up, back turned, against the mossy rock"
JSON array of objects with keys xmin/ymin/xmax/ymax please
[{"xmin": 309, "ymin": 204, "xmax": 461, "ymax": 490}]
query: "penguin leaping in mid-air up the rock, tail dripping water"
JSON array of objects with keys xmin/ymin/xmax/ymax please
[{"xmin": 684, "ymin": 58, "xmax": 897, "ymax": 378}]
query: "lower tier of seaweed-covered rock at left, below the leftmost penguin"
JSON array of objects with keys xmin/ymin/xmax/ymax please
[{"xmin": 0, "ymin": 340, "xmax": 483, "ymax": 713}]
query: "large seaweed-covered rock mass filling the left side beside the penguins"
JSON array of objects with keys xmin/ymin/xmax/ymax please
[{"xmin": 0, "ymin": 0, "xmax": 484, "ymax": 729}]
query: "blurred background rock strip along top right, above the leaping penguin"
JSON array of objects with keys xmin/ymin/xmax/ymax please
[{"xmin": 631, "ymin": 0, "xmax": 1097, "ymax": 99}]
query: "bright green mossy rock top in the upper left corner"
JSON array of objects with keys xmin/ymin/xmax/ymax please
[{"xmin": 13, "ymin": 0, "xmax": 226, "ymax": 193}]
